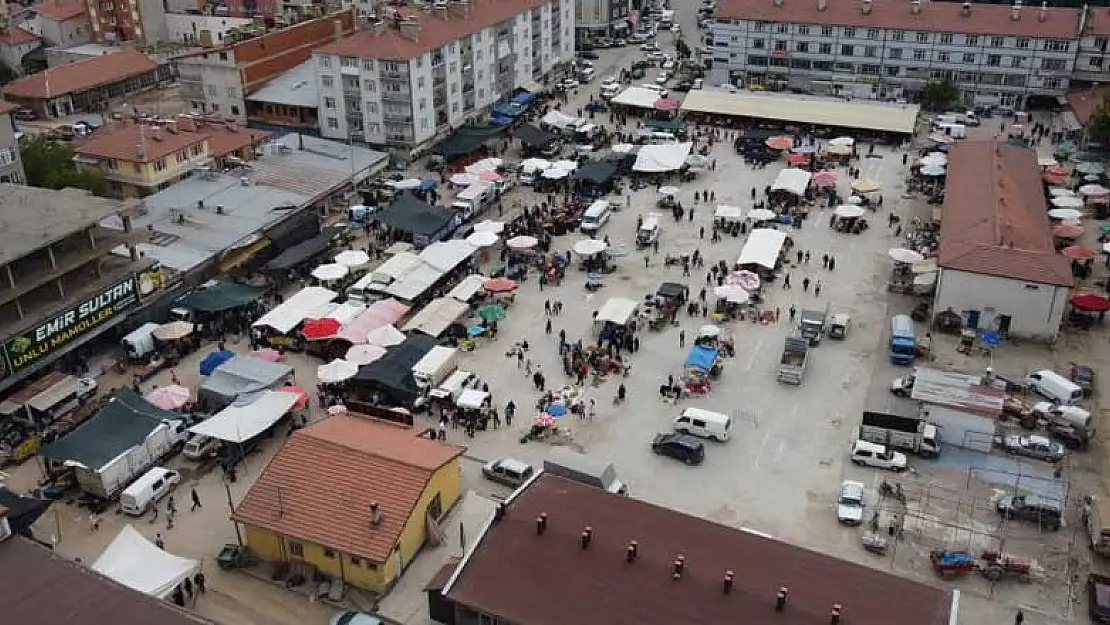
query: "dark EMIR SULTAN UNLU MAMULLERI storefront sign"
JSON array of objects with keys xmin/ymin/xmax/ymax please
[{"xmin": 4, "ymin": 275, "xmax": 139, "ymax": 373}]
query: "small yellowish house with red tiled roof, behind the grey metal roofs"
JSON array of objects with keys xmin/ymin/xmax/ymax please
[{"xmin": 74, "ymin": 115, "xmax": 270, "ymax": 198}]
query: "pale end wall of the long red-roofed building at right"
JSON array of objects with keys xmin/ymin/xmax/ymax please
[{"xmin": 932, "ymin": 270, "xmax": 1068, "ymax": 339}]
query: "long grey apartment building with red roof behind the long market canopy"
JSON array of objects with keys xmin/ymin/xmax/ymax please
[{"xmin": 706, "ymin": 0, "xmax": 1083, "ymax": 108}]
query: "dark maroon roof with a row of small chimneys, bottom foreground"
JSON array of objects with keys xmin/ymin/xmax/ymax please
[{"xmin": 446, "ymin": 475, "xmax": 950, "ymax": 625}]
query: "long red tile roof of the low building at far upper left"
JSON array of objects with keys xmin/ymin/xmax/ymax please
[{"xmin": 3, "ymin": 49, "xmax": 158, "ymax": 100}]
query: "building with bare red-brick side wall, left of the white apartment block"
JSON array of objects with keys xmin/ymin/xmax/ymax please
[{"xmin": 176, "ymin": 10, "xmax": 354, "ymax": 124}]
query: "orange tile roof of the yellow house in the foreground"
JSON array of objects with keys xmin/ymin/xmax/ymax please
[{"xmin": 233, "ymin": 415, "xmax": 465, "ymax": 562}]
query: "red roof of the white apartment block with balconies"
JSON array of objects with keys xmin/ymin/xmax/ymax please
[{"xmin": 316, "ymin": 0, "xmax": 548, "ymax": 61}]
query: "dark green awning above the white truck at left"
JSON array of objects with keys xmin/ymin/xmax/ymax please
[{"xmin": 39, "ymin": 389, "xmax": 183, "ymax": 471}]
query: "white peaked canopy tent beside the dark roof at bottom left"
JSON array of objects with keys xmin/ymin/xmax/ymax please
[{"xmin": 93, "ymin": 526, "xmax": 199, "ymax": 599}]
